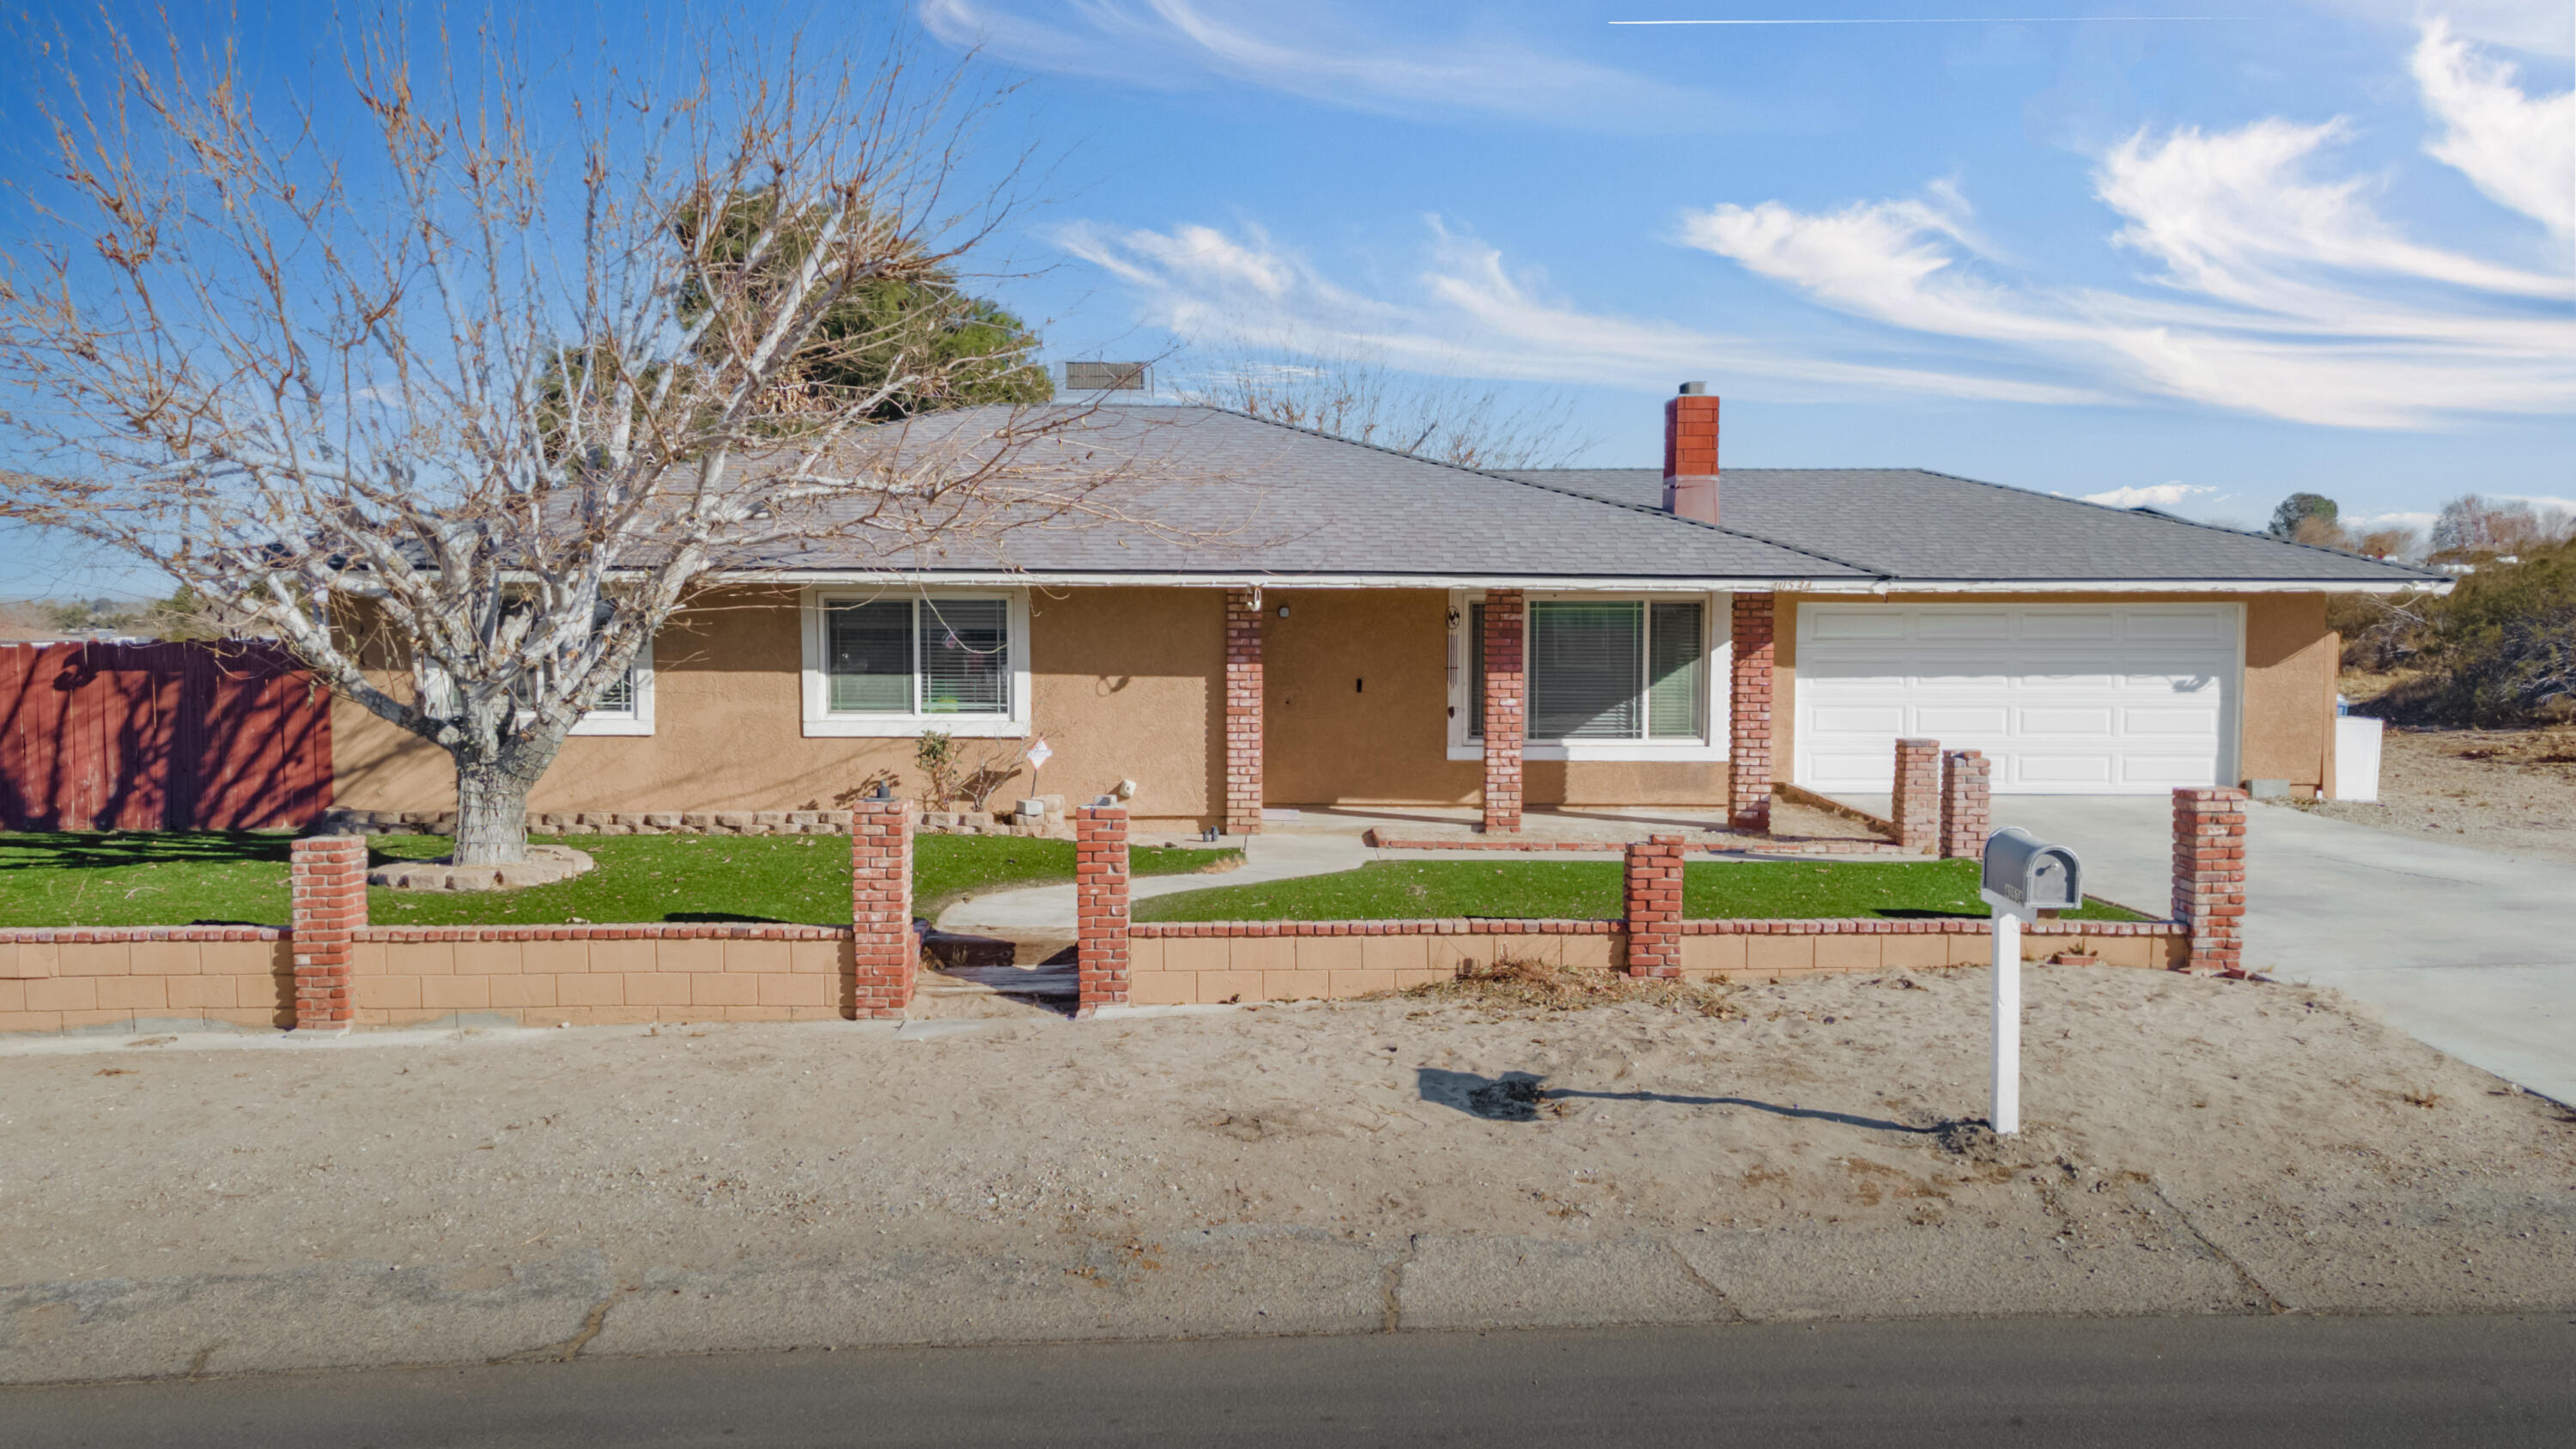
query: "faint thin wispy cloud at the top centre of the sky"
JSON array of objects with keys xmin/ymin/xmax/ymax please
[{"xmin": 922, "ymin": 0, "xmax": 1734, "ymax": 129}]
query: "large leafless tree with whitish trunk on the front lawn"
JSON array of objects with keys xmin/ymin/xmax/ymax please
[{"xmin": 0, "ymin": 13, "xmax": 1149, "ymax": 864}]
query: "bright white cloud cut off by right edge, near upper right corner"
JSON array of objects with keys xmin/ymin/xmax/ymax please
[{"xmin": 2414, "ymin": 18, "xmax": 2576, "ymax": 237}]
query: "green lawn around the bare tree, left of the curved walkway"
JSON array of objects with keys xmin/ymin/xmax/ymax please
[{"xmin": 0, "ymin": 833, "xmax": 1236, "ymax": 926}]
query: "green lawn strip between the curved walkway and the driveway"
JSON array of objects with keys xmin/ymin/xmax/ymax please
[{"xmin": 1136, "ymin": 861, "xmax": 2143, "ymax": 921}]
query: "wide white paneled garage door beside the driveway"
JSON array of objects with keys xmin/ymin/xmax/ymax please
[{"xmin": 1795, "ymin": 603, "xmax": 2241, "ymax": 795}]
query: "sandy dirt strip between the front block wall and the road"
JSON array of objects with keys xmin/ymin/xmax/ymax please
[{"xmin": 0, "ymin": 967, "xmax": 2576, "ymax": 1382}]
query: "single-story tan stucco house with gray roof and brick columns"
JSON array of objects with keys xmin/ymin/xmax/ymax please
[{"xmin": 335, "ymin": 384, "xmax": 2439, "ymax": 833}]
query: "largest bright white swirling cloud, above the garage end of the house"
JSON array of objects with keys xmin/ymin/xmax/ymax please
[{"xmin": 1682, "ymin": 23, "xmax": 2576, "ymax": 428}]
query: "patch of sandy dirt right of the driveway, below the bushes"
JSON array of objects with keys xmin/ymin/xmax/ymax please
[{"xmin": 2298, "ymin": 728, "xmax": 2576, "ymax": 861}]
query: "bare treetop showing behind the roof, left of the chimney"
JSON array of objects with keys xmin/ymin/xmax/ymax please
[{"xmin": 1172, "ymin": 350, "xmax": 1592, "ymax": 469}]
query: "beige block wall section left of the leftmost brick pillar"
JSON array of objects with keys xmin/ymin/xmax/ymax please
[{"xmin": 0, "ymin": 941, "xmax": 296, "ymax": 1032}]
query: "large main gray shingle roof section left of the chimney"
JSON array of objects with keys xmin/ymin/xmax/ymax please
[{"xmin": 732, "ymin": 407, "xmax": 1870, "ymax": 580}]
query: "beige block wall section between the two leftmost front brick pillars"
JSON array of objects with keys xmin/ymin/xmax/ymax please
[{"xmin": 350, "ymin": 939, "xmax": 850, "ymax": 1026}]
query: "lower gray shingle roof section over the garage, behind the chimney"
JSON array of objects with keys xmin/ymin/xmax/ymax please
[{"xmin": 1512, "ymin": 466, "xmax": 2442, "ymax": 577}]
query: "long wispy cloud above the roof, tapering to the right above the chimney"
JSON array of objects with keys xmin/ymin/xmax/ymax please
[{"xmin": 1056, "ymin": 216, "xmax": 2105, "ymax": 402}]
